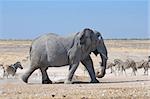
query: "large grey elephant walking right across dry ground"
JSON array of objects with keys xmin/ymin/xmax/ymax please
[{"xmin": 22, "ymin": 28, "xmax": 108, "ymax": 84}]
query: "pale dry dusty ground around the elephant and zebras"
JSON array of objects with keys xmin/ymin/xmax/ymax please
[{"xmin": 0, "ymin": 40, "xmax": 150, "ymax": 99}]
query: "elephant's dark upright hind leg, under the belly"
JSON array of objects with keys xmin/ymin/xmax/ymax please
[{"xmin": 40, "ymin": 67, "xmax": 52, "ymax": 84}]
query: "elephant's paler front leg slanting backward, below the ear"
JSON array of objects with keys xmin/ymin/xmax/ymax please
[{"xmin": 64, "ymin": 63, "xmax": 79, "ymax": 84}]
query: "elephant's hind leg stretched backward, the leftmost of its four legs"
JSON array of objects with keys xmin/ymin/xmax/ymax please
[{"xmin": 22, "ymin": 67, "xmax": 38, "ymax": 83}]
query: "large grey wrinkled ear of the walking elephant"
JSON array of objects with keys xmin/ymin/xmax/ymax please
[{"xmin": 68, "ymin": 28, "xmax": 93, "ymax": 64}]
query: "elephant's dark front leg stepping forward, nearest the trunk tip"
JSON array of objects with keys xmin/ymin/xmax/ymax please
[{"xmin": 81, "ymin": 56, "xmax": 99, "ymax": 83}]
